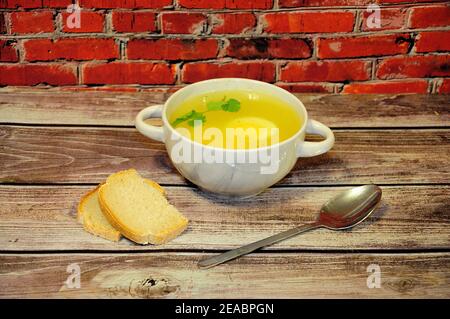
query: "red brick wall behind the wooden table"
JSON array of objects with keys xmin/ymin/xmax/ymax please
[{"xmin": 0, "ymin": 0, "xmax": 450, "ymax": 93}]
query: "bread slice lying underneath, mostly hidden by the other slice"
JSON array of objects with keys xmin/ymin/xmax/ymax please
[{"xmin": 78, "ymin": 179, "xmax": 165, "ymax": 241}]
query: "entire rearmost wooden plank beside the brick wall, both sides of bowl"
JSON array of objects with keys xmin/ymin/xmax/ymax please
[{"xmin": 0, "ymin": 88, "xmax": 450, "ymax": 128}]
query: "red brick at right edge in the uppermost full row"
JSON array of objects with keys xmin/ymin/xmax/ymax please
[{"xmin": 409, "ymin": 6, "xmax": 450, "ymax": 28}]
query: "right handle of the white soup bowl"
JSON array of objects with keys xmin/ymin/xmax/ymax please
[{"xmin": 297, "ymin": 120, "xmax": 334, "ymax": 157}]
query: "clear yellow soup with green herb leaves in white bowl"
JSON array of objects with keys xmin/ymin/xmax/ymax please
[{"xmin": 169, "ymin": 90, "xmax": 303, "ymax": 149}]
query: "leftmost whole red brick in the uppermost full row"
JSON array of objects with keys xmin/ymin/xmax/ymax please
[{"xmin": 11, "ymin": 11, "xmax": 55, "ymax": 34}]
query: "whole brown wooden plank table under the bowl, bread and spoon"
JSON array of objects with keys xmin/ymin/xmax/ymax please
[{"xmin": 0, "ymin": 89, "xmax": 450, "ymax": 298}]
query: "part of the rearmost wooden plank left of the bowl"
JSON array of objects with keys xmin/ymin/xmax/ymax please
[{"xmin": 0, "ymin": 90, "xmax": 169, "ymax": 126}]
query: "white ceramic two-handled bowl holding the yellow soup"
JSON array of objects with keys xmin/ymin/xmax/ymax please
[{"xmin": 135, "ymin": 78, "xmax": 334, "ymax": 197}]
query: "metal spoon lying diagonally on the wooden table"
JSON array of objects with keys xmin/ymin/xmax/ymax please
[{"xmin": 198, "ymin": 185, "xmax": 381, "ymax": 268}]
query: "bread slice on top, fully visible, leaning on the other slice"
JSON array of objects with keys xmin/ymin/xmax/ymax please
[{"xmin": 98, "ymin": 169, "xmax": 188, "ymax": 245}]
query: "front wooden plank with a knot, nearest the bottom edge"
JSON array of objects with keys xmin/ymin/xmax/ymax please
[{"xmin": 0, "ymin": 253, "xmax": 450, "ymax": 298}]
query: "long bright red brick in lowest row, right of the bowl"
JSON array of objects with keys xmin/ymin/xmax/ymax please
[{"xmin": 342, "ymin": 80, "xmax": 428, "ymax": 94}]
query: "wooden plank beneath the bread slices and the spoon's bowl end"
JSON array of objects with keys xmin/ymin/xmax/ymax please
[{"xmin": 0, "ymin": 186, "xmax": 450, "ymax": 251}]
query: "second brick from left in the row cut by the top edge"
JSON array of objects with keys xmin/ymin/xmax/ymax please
[{"xmin": 79, "ymin": 0, "xmax": 172, "ymax": 9}]
